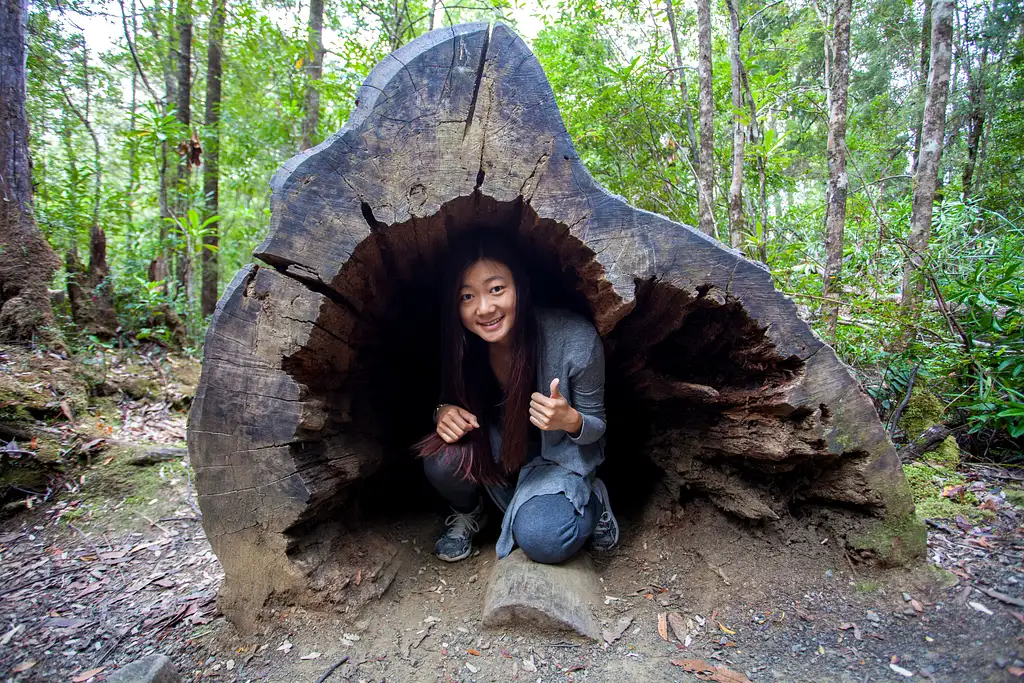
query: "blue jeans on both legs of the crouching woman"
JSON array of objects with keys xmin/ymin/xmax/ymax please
[{"xmin": 423, "ymin": 456, "xmax": 601, "ymax": 564}]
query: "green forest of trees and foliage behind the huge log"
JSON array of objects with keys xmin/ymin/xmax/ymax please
[{"xmin": 5, "ymin": 0, "xmax": 1024, "ymax": 461}]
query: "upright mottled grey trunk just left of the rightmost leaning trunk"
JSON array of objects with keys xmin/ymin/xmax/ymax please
[{"xmin": 822, "ymin": 0, "xmax": 853, "ymax": 338}]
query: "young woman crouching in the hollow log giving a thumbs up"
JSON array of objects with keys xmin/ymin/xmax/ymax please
[{"xmin": 417, "ymin": 236, "xmax": 618, "ymax": 563}]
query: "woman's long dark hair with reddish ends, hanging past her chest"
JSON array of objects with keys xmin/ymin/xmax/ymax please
[{"xmin": 414, "ymin": 235, "xmax": 538, "ymax": 484}]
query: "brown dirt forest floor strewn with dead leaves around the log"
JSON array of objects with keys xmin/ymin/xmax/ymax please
[{"xmin": 0, "ymin": 349, "xmax": 1024, "ymax": 683}]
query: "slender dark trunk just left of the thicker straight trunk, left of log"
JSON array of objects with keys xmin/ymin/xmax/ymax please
[{"xmin": 174, "ymin": 0, "xmax": 193, "ymax": 296}]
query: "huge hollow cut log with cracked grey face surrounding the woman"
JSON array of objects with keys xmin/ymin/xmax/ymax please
[{"xmin": 188, "ymin": 24, "xmax": 924, "ymax": 630}]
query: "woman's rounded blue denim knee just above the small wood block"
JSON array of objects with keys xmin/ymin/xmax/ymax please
[{"xmin": 512, "ymin": 494, "xmax": 587, "ymax": 564}]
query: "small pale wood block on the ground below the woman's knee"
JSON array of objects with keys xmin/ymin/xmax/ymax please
[{"xmin": 482, "ymin": 549, "xmax": 601, "ymax": 640}]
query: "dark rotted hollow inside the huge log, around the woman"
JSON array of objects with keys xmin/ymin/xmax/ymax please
[{"xmin": 278, "ymin": 193, "xmax": 828, "ymax": 589}]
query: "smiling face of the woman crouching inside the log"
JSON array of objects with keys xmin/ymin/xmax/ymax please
[{"xmin": 459, "ymin": 259, "xmax": 515, "ymax": 344}]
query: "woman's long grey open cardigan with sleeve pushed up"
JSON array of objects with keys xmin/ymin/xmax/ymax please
[{"xmin": 490, "ymin": 308, "xmax": 605, "ymax": 559}]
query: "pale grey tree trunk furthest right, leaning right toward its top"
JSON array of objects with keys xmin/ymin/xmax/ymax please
[{"xmin": 902, "ymin": 0, "xmax": 953, "ymax": 306}]
